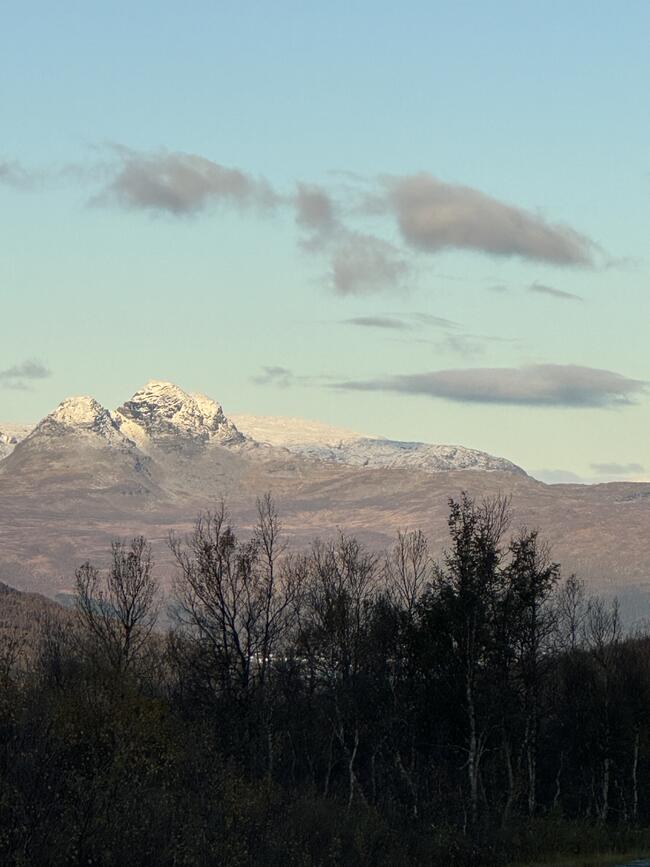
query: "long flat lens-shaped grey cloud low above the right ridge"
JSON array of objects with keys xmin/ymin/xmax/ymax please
[{"xmin": 335, "ymin": 364, "xmax": 647, "ymax": 408}]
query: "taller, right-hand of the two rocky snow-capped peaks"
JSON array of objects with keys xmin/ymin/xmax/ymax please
[{"xmin": 115, "ymin": 379, "xmax": 244, "ymax": 444}]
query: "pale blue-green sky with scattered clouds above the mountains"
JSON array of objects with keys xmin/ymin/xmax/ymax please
[{"xmin": 0, "ymin": 0, "xmax": 650, "ymax": 481}]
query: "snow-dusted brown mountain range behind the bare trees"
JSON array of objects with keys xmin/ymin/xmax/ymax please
[{"xmin": 0, "ymin": 380, "xmax": 650, "ymax": 613}]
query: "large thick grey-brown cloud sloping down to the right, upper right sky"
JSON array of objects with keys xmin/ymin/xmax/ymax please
[{"xmin": 385, "ymin": 172, "xmax": 595, "ymax": 265}]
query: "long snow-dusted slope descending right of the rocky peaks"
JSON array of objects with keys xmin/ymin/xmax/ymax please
[{"xmin": 232, "ymin": 413, "xmax": 525, "ymax": 475}]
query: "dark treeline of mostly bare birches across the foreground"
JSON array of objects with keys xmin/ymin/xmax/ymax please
[{"xmin": 0, "ymin": 496, "xmax": 650, "ymax": 867}]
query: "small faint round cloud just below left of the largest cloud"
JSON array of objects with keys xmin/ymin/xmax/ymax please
[{"xmin": 329, "ymin": 232, "xmax": 409, "ymax": 295}]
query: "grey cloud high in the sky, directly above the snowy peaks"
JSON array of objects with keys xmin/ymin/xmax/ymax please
[{"xmin": 93, "ymin": 147, "xmax": 277, "ymax": 216}]
